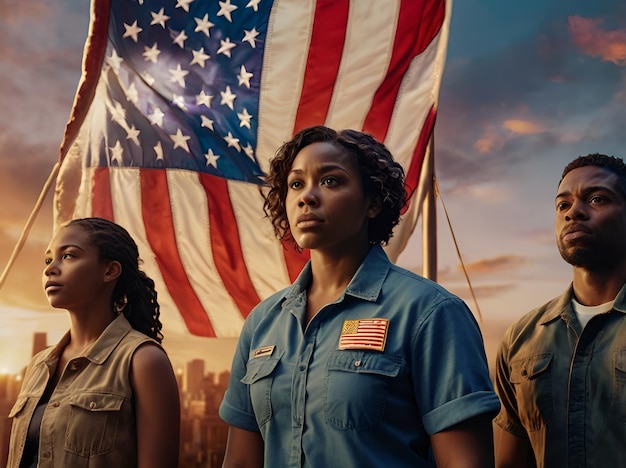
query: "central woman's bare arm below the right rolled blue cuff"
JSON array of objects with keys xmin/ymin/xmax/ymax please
[{"xmin": 430, "ymin": 416, "xmax": 494, "ymax": 468}]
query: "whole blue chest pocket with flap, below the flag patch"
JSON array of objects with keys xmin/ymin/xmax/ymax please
[{"xmin": 324, "ymin": 351, "xmax": 403, "ymax": 430}]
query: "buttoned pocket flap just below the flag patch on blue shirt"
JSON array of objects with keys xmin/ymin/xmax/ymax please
[{"xmin": 328, "ymin": 351, "xmax": 402, "ymax": 377}]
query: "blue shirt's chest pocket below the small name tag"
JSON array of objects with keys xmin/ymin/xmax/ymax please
[{"xmin": 241, "ymin": 356, "xmax": 280, "ymax": 427}]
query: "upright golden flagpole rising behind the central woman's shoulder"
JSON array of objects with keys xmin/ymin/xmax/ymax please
[{"xmin": 422, "ymin": 136, "xmax": 437, "ymax": 281}]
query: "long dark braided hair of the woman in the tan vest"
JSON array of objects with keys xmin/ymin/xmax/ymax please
[{"xmin": 66, "ymin": 218, "xmax": 163, "ymax": 343}]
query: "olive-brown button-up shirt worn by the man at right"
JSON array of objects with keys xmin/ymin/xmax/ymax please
[{"xmin": 495, "ymin": 286, "xmax": 626, "ymax": 468}]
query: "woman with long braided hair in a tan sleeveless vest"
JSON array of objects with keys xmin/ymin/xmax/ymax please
[{"xmin": 7, "ymin": 218, "xmax": 180, "ymax": 468}]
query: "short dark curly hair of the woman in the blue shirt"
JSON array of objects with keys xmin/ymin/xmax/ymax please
[{"xmin": 263, "ymin": 125, "xmax": 407, "ymax": 249}]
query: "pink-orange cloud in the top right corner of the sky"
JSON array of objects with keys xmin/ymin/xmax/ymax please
[{"xmin": 568, "ymin": 16, "xmax": 626, "ymax": 65}]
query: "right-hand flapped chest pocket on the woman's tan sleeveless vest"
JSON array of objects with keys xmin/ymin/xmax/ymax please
[{"xmin": 65, "ymin": 393, "xmax": 125, "ymax": 457}]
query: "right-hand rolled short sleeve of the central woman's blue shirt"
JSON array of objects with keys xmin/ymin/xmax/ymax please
[{"xmin": 412, "ymin": 297, "xmax": 500, "ymax": 435}]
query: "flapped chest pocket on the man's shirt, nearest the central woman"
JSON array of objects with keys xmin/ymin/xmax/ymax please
[{"xmin": 510, "ymin": 354, "xmax": 554, "ymax": 432}]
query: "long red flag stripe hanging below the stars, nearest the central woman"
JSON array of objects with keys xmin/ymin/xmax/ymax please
[{"xmin": 200, "ymin": 173, "xmax": 261, "ymax": 317}]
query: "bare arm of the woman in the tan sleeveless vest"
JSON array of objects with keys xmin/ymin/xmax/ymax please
[{"xmin": 130, "ymin": 344, "xmax": 180, "ymax": 468}]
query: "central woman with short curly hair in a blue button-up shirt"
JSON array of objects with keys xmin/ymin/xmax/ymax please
[{"xmin": 220, "ymin": 126, "xmax": 500, "ymax": 468}]
